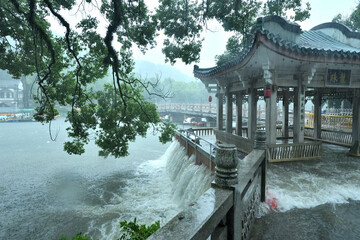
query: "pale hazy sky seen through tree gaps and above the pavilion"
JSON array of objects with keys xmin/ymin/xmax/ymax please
[{"xmin": 49, "ymin": 0, "xmax": 358, "ymax": 76}]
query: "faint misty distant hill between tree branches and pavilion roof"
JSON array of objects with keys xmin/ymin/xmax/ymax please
[{"xmin": 134, "ymin": 61, "xmax": 196, "ymax": 82}]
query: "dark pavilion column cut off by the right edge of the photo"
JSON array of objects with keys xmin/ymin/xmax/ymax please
[{"xmin": 348, "ymin": 89, "xmax": 360, "ymax": 156}]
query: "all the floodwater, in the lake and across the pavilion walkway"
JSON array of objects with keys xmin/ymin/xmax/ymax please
[{"xmin": 0, "ymin": 119, "xmax": 360, "ymax": 240}]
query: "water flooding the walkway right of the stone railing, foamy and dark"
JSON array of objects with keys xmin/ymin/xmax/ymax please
[{"xmin": 253, "ymin": 144, "xmax": 360, "ymax": 240}]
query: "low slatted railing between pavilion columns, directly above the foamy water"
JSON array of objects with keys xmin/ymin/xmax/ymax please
[{"xmin": 267, "ymin": 142, "xmax": 321, "ymax": 162}]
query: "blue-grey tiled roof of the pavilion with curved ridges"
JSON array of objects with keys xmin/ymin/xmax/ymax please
[{"xmin": 194, "ymin": 16, "xmax": 360, "ymax": 77}]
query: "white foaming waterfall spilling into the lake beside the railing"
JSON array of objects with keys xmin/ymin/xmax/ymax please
[{"xmin": 89, "ymin": 141, "xmax": 212, "ymax": 239}]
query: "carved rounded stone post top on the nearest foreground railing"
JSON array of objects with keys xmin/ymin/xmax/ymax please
[{"xmin": 215, "ymin": 143, "xmax": 238, "ymax": 186}]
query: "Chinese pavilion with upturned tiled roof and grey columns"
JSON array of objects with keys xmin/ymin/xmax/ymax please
[{"xmin": 194, "ymin": 16, "xmax": 360, "ymax": 156}]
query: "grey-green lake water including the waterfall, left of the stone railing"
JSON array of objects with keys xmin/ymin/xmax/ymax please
[{"xmin": 0, "ymin": 119, "xmax": 211, "ymax": 239}]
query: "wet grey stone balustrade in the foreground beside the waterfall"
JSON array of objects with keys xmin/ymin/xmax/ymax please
[{"xmin": 148, "ymin": 133, "xmax": 266, "ymax": 240}]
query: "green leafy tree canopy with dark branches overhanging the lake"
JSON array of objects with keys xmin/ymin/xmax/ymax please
[{"xmin": 0, "ymin": 0, "xmax": 309, "ymax": 157}]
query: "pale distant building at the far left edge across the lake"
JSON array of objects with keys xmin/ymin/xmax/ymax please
[{"xmin": 0, "ymin": 71, "xmax": 23, "ymax": 109}]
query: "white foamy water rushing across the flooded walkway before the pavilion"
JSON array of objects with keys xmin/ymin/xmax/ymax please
[{"xmin": 267, "ymin": 161, "xmax": 360, "ymax": 212}]
